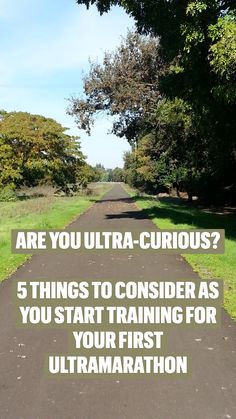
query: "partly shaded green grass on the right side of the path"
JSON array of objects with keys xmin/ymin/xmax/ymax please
[{"xmin": 126, "ymin": 187, "xmax": 236, "ymax": 319}]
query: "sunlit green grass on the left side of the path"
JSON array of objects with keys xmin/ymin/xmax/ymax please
[{"xmin": 0, "ymin": 184, "xmax": 111, "ymax": 281}]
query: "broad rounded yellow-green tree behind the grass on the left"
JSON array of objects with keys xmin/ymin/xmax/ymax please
[{"xmin": 0, "ymin": 112, "xmax": 85, "ymax": 188}]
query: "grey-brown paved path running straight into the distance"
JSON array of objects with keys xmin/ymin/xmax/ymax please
[{"xmin": 0, "ymin": 185, "xmax": 236, "ymax": 419}]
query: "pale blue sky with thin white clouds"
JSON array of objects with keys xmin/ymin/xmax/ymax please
[{"xmin": 0, "ymin": 0, "xmax": 134, "ymax": 168}]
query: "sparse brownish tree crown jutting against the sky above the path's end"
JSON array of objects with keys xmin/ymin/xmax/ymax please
[{"xmin": 68, "ymin": 32, "xmax": 162, "ymax": 143}]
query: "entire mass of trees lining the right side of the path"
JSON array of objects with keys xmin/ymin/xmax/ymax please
[{"xmin": 68, "ymin": 0, "xmax": 236, "ymax": 203}]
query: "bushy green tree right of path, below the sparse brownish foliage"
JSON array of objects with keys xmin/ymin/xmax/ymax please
[{"xmin": 125, "ymin": 99, "xmax": 195, "ymax": 197}]
